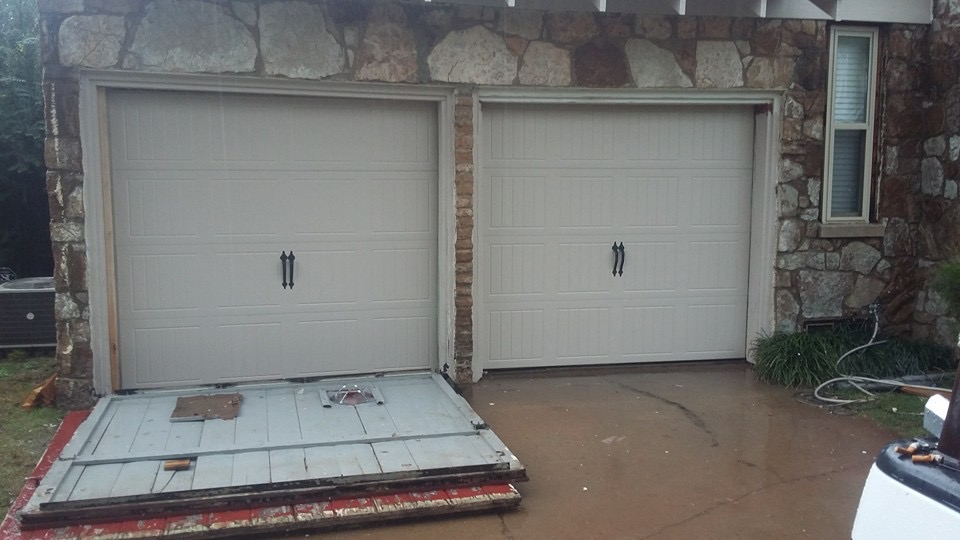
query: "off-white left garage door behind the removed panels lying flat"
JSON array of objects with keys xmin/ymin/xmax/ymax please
[{"xmin": 108, "ymin": 91, "xmax": 437, "ymax": 388}]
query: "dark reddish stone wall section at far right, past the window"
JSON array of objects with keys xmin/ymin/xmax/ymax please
[{"xmin": 904, "ymin": 0, "xmax": 960, "ymax": 343}]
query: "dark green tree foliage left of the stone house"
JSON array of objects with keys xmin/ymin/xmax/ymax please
[{"xmin": 0, "ymin": 0, "xmax": 52, "ymax": 277}]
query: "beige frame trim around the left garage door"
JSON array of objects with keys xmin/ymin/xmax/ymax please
[{"xmin": 80, "ymin": 71, "xmax": 456, "ymax": 395}]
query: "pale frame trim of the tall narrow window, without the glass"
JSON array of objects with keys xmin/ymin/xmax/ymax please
[{"xmin": 822, "ymin": 26, "xmax": 880, "ymax": 224}]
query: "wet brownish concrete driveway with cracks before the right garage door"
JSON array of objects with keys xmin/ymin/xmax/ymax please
[{"xmin": 312, "ymin": 362, "xmax": 892, "ymax": 540}]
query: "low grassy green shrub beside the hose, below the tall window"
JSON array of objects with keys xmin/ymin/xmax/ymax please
[{"xmin": 752, "ymin": 328, "xmax": 955, "ymax": 387}]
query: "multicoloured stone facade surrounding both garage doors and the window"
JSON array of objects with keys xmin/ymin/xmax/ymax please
[{"xmin": 40, "ymin": 0, "xmax": 960, "ymax": 407}]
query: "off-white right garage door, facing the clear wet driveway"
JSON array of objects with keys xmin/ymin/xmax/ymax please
[{"xmin": 477, "ymin": 105, "xmax": 753, "ymax": 368}]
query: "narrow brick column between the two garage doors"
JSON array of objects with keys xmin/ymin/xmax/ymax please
[{"xmin": 453, "ymin": 88, "xmax": 474, "ymax": 384}]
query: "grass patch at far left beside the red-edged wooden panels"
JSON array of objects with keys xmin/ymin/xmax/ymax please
[{"xmin": 0, "ymin": 355, "xmax": 65, "ymax": 515}]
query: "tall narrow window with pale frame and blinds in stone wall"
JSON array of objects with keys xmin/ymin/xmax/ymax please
[{"xmin": 823, "ymin": 26, "xmax": 877, "ymax": 223}]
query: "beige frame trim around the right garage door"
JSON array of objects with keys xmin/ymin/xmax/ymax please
[{"xmin": 473, "ymin": 88, "xmax": 783, "ymax": 380}]
